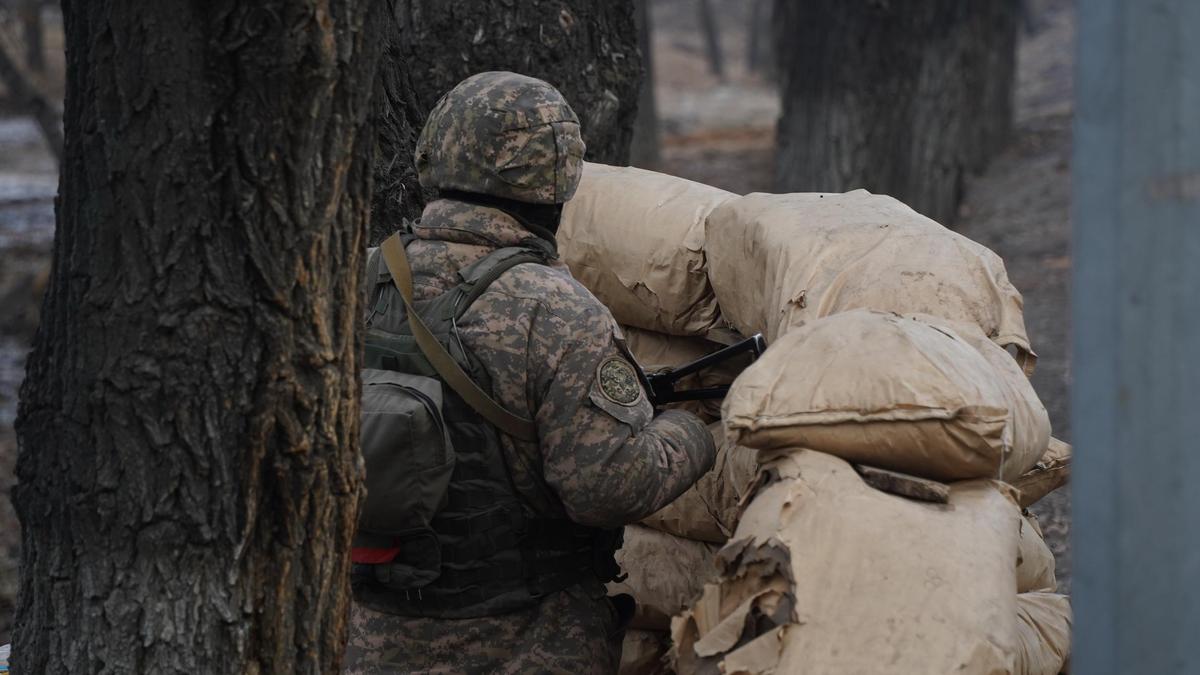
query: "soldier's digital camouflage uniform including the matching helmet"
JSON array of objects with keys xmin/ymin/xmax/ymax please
[{"xmin": 347, "ymin": 73, "xmax": 714, "ymax": 674}]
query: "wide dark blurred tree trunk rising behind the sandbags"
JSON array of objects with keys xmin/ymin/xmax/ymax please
[{"xmin": 775, "ymin": 0, "xmax": 1019, "ymax": 223}]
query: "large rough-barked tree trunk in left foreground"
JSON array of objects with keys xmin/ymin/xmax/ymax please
[{"xmin": 13, "ymin": 0, "xmax": 385, "ymax": 674}]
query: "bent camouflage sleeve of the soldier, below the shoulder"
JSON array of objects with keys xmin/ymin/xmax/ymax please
[{"xmin": 538, "ymin": 309, "xmax": 716, "ymax": 527}]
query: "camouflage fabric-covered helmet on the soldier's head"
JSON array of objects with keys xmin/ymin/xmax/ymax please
[{"xmin": 416, "ymin": 72, "xmax": 584, "ymax": 204}]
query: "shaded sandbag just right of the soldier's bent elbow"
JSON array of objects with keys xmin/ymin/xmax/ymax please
[{"xmin": 642, "ymin": 422, "xmax": 758, "ymax": 544}]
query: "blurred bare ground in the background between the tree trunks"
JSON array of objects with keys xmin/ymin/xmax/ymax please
[{"xmin": 0, "ymin": 0, "xmax": 1074, "ymax": 644}]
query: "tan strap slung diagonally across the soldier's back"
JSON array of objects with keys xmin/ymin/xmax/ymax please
[{"xmin": 379, "ymin": 234, "xmax": 538, "ymax": 442}]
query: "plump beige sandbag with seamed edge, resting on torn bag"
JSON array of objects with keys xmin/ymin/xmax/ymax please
[{"xmin": 721, "ymin": 310, "xmax": 1050, "ymax": 480}]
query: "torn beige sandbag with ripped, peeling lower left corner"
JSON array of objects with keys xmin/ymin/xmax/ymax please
[{"xmin": 671, "ymin": 450, "xmax": 1020, "ymax": 675}]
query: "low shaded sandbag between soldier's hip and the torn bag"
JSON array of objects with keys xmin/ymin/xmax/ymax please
[{"xmin": 608, "ymin": 525, "xmax": 718, "ymax": 631}]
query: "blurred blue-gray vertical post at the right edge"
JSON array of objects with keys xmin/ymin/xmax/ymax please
[{"xmin": 1072, "ymin": 0, "xmax": 1200, "ymax": 675}]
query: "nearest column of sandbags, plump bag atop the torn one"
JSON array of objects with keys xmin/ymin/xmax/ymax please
[{"xmin": 672, "ymin": 310, "xmax": 1070, "ymax": 674}]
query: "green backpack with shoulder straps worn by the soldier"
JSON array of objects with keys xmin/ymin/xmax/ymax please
[{"xmin": 352, "ymin": 234, "xmax": 546, "ymax": 598}]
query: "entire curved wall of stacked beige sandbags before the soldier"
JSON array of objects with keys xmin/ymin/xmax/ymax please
[{"xmin": 559, "ymin": 165, "xmax": 1070, "ymax": 675}]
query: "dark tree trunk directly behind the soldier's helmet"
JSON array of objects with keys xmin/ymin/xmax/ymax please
[{"xmin": 371, "ymin": 0, "xmax": 642, "ymax": 241}]
